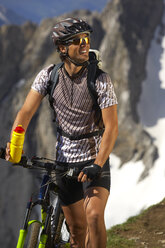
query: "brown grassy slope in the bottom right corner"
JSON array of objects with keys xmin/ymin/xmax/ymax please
[{"xmin": 107, "ymin": 199, "xmax": 165, "ymax": 248}]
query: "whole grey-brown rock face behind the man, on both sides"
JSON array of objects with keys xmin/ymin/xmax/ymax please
[{"xmin": 0, "ymin": 0, "xmax": 163, "ymax": 248}]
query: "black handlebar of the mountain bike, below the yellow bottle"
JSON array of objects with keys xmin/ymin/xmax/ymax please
[{"xmin": 0, "ymin": 147, "xmax": 80, "ymax": 178}]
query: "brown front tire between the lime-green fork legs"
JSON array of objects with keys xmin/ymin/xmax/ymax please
[{"xmin": 27, "ymin": 222, "xmax": 40, "ymax": 248}]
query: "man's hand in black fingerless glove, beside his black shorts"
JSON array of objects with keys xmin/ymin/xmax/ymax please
[{"xmin": 78, "ymin": 164, "xmax": 101, "ymax": 182}]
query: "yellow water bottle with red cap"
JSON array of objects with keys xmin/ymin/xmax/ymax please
[{"xmin": 9, "ymin": 125, "xmax": 25, "ymax": 163}]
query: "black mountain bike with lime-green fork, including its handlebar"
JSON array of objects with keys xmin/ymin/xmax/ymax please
[{"xmin": 0, "ymin": 148, "xmax": 71, "ymax": 248}]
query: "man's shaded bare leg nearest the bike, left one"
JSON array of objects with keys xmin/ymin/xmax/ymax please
[{"xmin": 62, "ymin": 200, "xmax": 87, "ymax": 248}]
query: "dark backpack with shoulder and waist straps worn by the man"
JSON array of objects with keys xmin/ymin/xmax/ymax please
[{"xmin": 47, "ymin": 49, "xmax": 104, "ymax": 140}]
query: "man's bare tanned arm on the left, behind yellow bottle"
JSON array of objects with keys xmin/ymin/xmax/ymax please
[{"xmin": 6, "ymin": 89, "xmax": 43, "ymax": 160}]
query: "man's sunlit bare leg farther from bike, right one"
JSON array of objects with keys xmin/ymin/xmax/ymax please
[{"xmin": 84, "ymin": 187, "xmax": 109, "ymax": 248}]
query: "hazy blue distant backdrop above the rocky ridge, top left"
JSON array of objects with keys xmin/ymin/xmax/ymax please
[{"xmin": 1, "ymin": 0, "xmax": 107, "ymax": 23}]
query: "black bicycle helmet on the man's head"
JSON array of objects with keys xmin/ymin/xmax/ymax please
[{"xmin": 52, "ymin": 18, "xmax": 93, "ymax": 45}]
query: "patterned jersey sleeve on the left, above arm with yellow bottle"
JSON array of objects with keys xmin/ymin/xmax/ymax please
[{"xmin": 31, "ymin": 65, "xmax": 53, "ymax": 96}]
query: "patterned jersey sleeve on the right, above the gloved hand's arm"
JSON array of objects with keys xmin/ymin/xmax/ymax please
[{"xmin": 96, "ymin": 72, "xmax": 118, "ymax": 109}]
